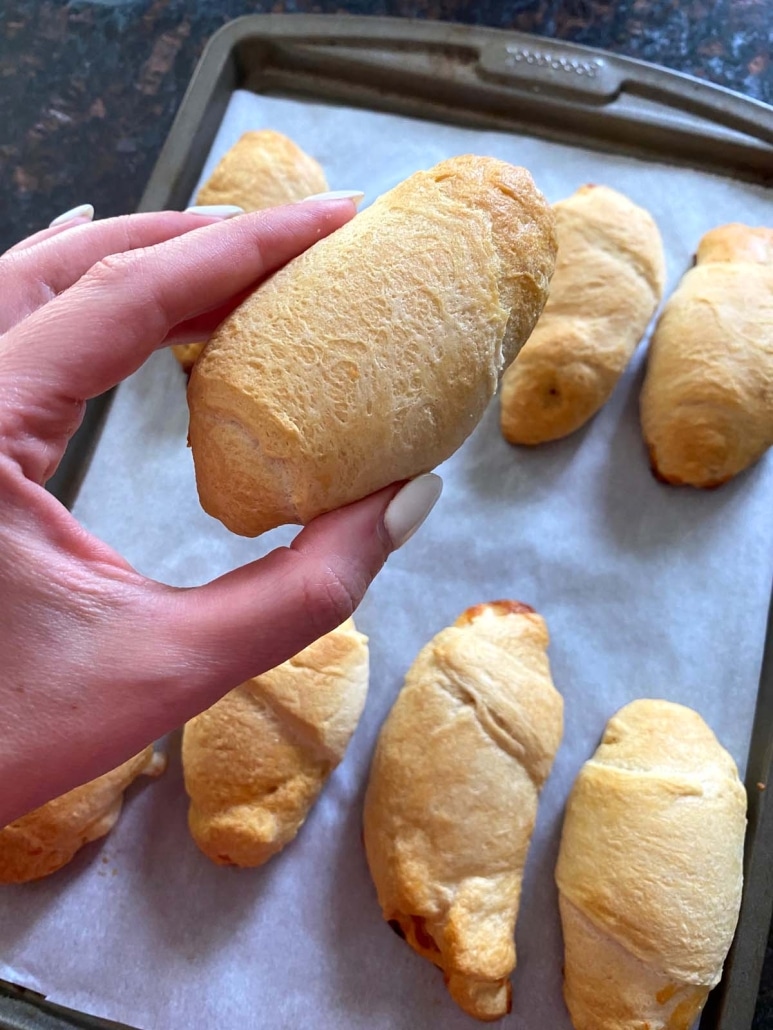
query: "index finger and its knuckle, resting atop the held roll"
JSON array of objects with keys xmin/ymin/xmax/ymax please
[{"xmin": 0, "ymin": 201, "xmax": 355, "ymax": 483}]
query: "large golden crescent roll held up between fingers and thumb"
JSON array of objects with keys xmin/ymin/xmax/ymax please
[{"xmin": 188, "ymin": 157, "xmax": 556, "ymax": 537}]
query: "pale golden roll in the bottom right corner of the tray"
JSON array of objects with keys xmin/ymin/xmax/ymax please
[{"xmin": 556, "ymin": 700, "xmax": 746, "ymax": 1030}]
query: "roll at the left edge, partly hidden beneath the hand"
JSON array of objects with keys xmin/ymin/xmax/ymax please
[{"xmin": 0, "ymin": 748, "xmax": 166, "ymax": 884}]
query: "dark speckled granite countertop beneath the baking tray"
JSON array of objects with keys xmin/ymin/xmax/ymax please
[{"xmin": 0, "ymin": 0, "xmax": 773, "ymax": 1030}]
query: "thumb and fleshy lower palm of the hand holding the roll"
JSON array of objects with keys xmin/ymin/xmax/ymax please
[{"xmin": 0, "ymin": 466, "xmax": 439, "ymax": 825}]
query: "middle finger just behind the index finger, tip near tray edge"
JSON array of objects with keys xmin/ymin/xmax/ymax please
[{"xmin": 0, "ymin": 211, "xmax": 232, "ymax": 333}]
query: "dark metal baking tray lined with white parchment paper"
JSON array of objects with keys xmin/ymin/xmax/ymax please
[{"xmin": 6, "ymin": 14, "xmax": 773, "ymax": 1030}]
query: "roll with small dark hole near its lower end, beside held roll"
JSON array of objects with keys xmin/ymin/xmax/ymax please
[{"xmin": 501, "ymin": 185, "xmax": 666, "ymax": 444}]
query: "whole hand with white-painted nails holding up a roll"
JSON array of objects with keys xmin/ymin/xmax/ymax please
[{"xmin": 0, "ymin": 201, "xmax": 439, "ymax": 826}]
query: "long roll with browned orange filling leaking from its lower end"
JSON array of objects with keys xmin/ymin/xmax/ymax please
[{"xmin": 365, "ymin": 600, "xmax": 563, "ymax": 1020}]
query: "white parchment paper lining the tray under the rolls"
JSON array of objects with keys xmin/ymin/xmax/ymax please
[{"xmin": 0, "ymin": 93, "xmax": 773, "ymax": 1030}]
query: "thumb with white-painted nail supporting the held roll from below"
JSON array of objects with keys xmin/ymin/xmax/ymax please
[{"xmin": 160, "ymin": 474, "xmax": 442, "ymax": 714}]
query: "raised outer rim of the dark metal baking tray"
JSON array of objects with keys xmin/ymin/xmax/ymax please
[{"xmin": 7, "ymin": 13, "xmax": 773, "ymax": 1030}]
